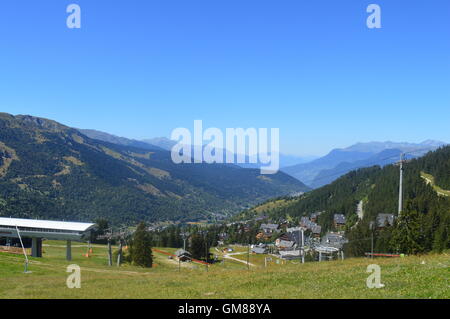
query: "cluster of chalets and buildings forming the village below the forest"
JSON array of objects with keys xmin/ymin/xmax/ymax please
[{"xmin": 166, "ymin": 212, "xmax": 395, "ymax": 267}]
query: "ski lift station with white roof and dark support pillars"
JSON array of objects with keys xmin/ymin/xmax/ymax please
[{"xmin": 0, "ymin": 217, "xmax": 94, "ymax": 260}]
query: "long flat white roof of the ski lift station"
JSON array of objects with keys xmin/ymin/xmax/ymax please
[{"xmin": 0, "ymin": 217, "xmax": 95, "ymax": 232}]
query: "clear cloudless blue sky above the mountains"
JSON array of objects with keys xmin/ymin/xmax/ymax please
[{"xmin": 0, "ymin": 0, "xmax": 450, "ymax": 155}]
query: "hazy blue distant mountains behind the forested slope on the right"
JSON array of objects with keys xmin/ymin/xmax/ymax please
[{"xmin": 281, "ymin": 140, "xmax": 447, "ymax": 188}]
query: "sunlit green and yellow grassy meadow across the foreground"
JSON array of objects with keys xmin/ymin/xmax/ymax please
[{"xmin": 0, "ymin": 241, "xmax": 450, "ymax": 299}]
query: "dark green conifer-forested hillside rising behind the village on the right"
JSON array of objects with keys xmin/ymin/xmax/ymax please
[{"xmin": 236, "ymin": 146, "xmax": 450, "ymax": 256}]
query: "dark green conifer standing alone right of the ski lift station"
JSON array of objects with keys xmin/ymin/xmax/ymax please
[{"xmin": 130, "ymin": 222, "xmax": 153, "ymax": 268}]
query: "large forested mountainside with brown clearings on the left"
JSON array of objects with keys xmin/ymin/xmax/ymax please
[{"xmin": 0, "ymin": 113, "xmax": 307, "ymax": 224}]
